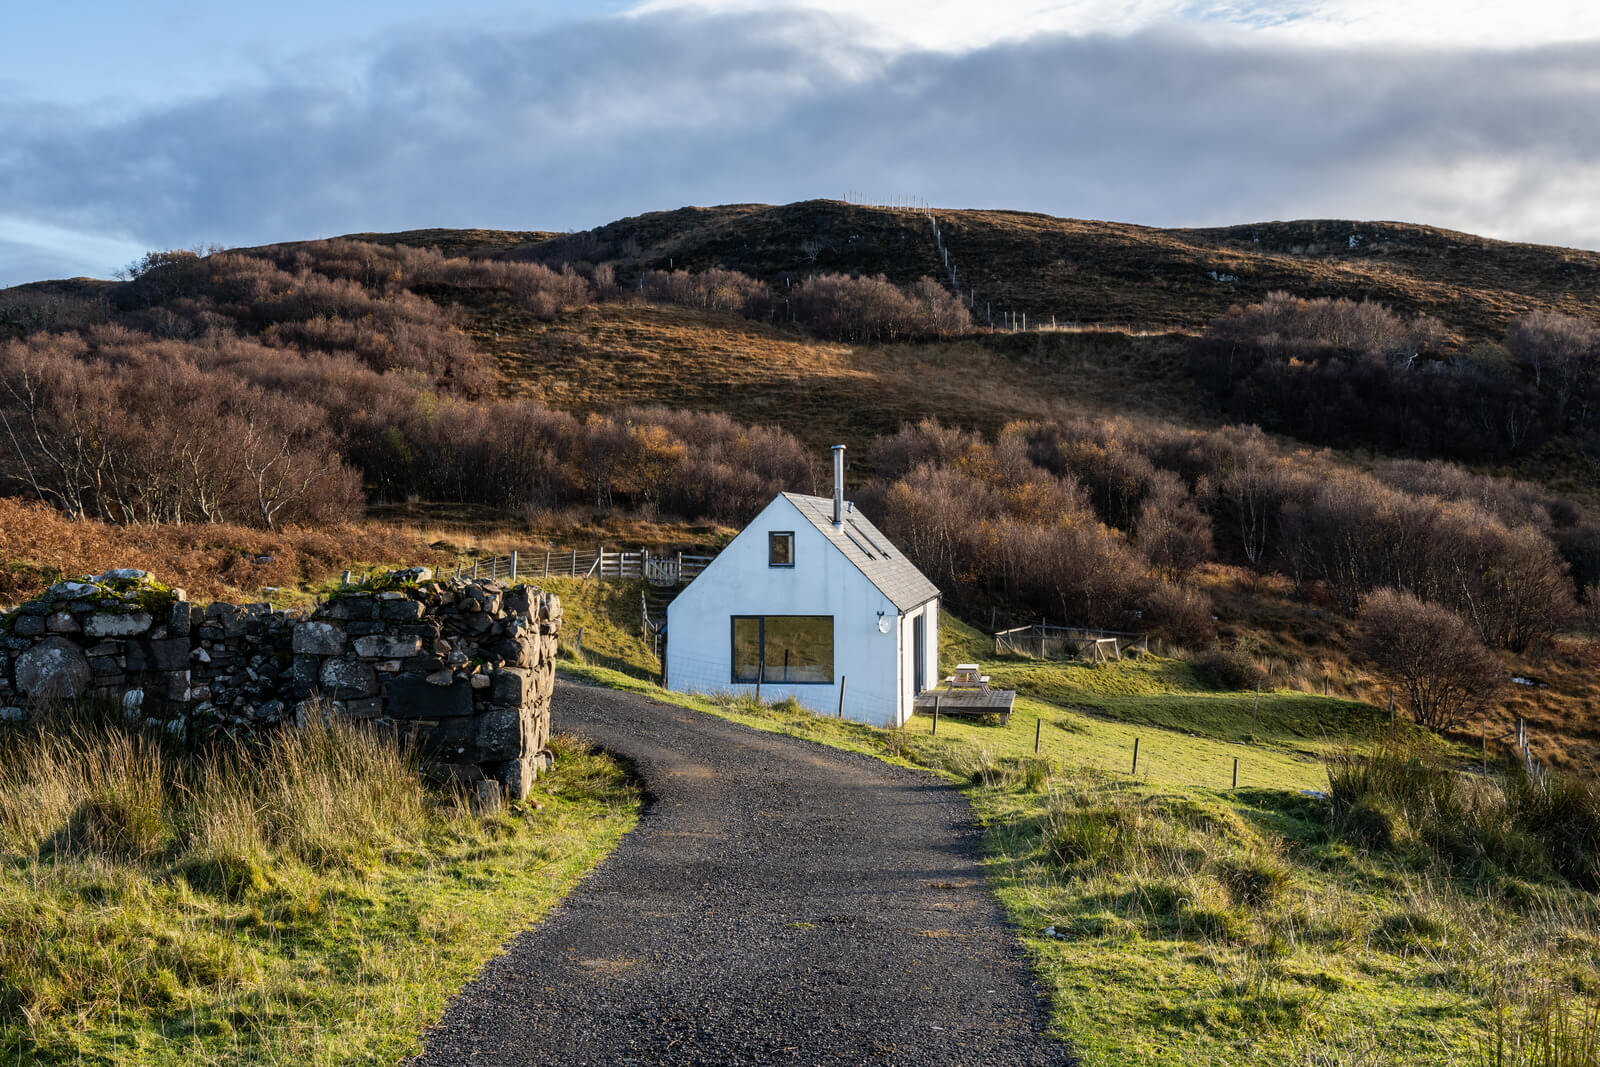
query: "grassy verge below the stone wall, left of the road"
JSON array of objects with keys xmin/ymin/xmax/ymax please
[{"xmin": 0, "ymin": 713, "xmax": 638, "ymax": 1064}]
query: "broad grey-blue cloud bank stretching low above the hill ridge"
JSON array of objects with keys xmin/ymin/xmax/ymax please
[{"xmin": 0, "ymin": 9, "xmax": 1600, "ymax": 282}]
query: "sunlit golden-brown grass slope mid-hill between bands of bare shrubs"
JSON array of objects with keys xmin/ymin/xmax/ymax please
[{"xmin": 467, "ymin": 294, "xmax": 1216, "ymax": 446}]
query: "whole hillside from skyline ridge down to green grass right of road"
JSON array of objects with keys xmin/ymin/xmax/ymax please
[{"xmin": 9, "ymin": 202, "xmax": 1600, "ymax": 1064}]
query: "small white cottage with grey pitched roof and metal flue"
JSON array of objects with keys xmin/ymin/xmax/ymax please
[{"xmin": 666, "ymin": 445, "xmax": 939, "ymax": 726}]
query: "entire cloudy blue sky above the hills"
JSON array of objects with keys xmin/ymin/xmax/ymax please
[{"xmin": 0, "ymin": 0, "xmax": 1600, "ymax": 286}]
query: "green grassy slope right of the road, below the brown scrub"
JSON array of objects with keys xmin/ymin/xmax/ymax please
[{"xmin": 547, "ymin": 590, "xmax": 1600, "ymax": 1067}]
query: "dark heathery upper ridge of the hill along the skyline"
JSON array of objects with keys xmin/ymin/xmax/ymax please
[{"xmin": 347, "ymin": 200, "xmax": 1600, "ymax": 341}]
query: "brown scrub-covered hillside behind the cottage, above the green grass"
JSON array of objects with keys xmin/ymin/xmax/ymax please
[{"xmin": 0, "ymin": 202, "xmax": 1600, "ymax": 777}]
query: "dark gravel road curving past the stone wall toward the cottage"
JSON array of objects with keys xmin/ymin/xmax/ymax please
[{"xmin": 413, "ymin": 681, "xmax": 1075, "ymax": 1067}]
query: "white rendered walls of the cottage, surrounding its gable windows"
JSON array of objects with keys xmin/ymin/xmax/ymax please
[{"xmin": 667, "ymin": 496, "xmax": 908, "ymax": 726}]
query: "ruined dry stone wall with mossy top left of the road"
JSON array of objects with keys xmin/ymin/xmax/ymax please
[{"xmin": 0, "ymin": 569, "xmax": 562, "ymax": 798}]
